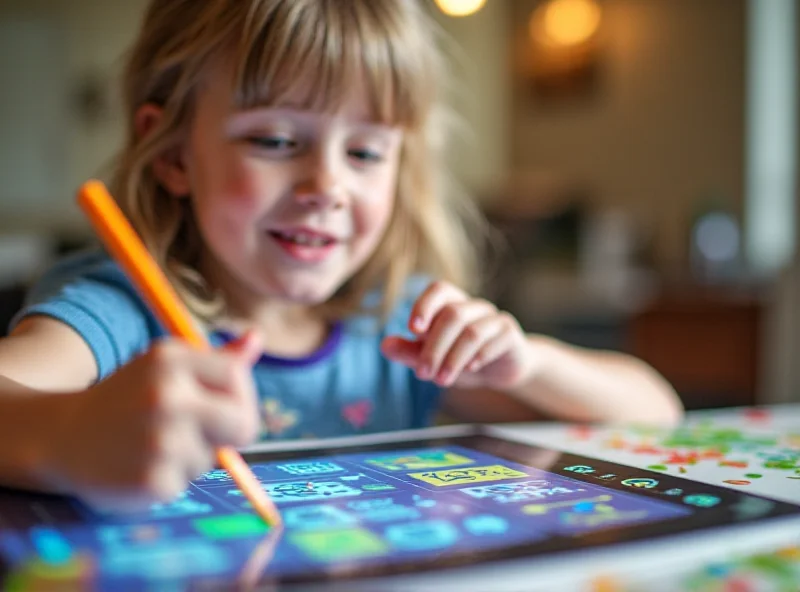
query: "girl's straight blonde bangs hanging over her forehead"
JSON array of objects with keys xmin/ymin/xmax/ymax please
[{"xmin": 231, "ymin": 0, "xmax": 433, "ymax": 128}]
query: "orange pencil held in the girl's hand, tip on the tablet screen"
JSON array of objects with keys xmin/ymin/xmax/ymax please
[{"xmin": 78, "ymin": 180, "xmax": 281, "ymax": 526}]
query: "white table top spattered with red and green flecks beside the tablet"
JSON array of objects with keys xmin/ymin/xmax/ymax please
[{"xmin": 506, "ymin": 405, "xmax": 800, "ymax": 592}]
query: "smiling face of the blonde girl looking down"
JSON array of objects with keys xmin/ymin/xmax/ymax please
[{"xmin": 173, "ymin": 71, "xmax": 403, "ymax": 305}]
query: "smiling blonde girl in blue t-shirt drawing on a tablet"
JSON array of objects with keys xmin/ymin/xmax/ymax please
[{"xmin": 0, "ymin": 0, "xmax": 681, "ymax": 507}]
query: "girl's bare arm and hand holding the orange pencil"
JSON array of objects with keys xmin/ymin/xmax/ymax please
[{"xmin": 0, "ymin": 317, "xmax": 259, "ymax": 508}]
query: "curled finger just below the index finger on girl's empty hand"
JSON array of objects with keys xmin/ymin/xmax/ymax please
[{"xmin": 417, "ymin": 300, "xmax": 495, "ymax": 380}]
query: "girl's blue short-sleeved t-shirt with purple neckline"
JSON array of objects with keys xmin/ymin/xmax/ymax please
[{"xmin": 12, "ymin": 251, "xmax": 440, "ymax": 439}]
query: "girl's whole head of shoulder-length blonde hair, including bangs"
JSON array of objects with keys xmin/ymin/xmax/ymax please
[{"xmin": 112, "ymin": 0, "xmax": 476, "ymax": 321}]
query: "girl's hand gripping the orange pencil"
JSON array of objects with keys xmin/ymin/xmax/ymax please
[{"xmin": 44, "ymin": 336, "xmax": 259, "ymax": 510}]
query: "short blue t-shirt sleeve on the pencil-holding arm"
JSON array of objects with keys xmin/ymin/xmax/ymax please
[{"xmin": 11, "ymin": 251, "xmax": 164, "ymax": 379}]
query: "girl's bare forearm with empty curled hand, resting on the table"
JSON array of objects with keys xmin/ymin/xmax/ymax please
[{"xmin": 384, "ymin": 282, "xmax": 683, "ymax": 424}]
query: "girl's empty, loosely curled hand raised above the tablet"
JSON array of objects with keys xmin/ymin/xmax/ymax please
[{"xmin": 382, "ymin": 282, "xmax": 533, "ymax": 390}]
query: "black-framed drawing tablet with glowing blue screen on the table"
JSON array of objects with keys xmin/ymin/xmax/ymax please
[{"xmin": 0, "ymin": 427, "xmax": 800, "ymax": 591}]
